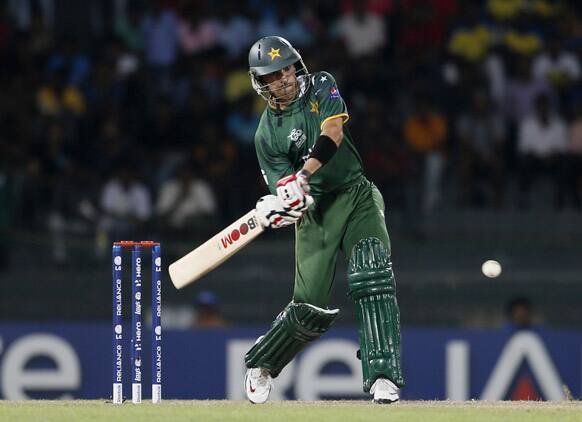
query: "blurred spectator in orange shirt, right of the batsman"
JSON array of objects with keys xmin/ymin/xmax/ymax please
[{"xmin": 404, "ymin": 98, "xmax": 448, "ymax": 214}]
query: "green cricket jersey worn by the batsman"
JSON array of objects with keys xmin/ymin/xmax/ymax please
[{"xmin": 255, "ymin": 72, "xmax": 363, "ymax": 197}]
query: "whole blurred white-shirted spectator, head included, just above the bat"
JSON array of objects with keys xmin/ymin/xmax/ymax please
[{"xmin": 156, "ymin": 163, "xmax": 217, "ymax": 235}]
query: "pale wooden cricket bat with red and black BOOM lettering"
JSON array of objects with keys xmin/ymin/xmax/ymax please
[{"xmin": 169, "ymin": 209, "xmax": 265, "ymax": 289}]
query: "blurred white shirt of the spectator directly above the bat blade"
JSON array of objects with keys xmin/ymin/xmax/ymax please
[{"xmin": 156, "ymin": 180, "xmax": 216, "ymax": 228}]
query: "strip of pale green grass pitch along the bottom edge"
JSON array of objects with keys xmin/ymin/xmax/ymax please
[{"xmin": 0, "ymin": 400, "xmax": 582, "ymax": 422}]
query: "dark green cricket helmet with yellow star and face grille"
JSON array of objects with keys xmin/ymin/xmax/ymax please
[{"xmin": 249, "ymin": 36, "xmax": 309, "ymax": 101}]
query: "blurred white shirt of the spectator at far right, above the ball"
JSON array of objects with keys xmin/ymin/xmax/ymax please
[{"xmin": 517, "ymin": 115, "xmax": 568, "ymax": 158}]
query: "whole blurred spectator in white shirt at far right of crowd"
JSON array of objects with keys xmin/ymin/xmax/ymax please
[{"xmin": 517, "ymin": 95, "xmax": 568, "ymax": 209}]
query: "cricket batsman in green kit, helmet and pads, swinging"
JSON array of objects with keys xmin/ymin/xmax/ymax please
[{"xmin": 245, "ymin": 36, "xmax": 404, "ymax": 403}]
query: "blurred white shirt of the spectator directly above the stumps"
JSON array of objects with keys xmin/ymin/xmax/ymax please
[{"xmin": 101, "ymin": 178, "xmax": 152, "ymax": 221}]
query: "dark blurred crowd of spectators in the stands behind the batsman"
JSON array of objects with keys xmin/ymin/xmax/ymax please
[{"xmin": 0, "ymin": 0, "xmax": 582, "ymax": 261}]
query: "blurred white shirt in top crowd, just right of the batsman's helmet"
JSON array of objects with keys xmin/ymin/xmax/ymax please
[{"xmin": 337, "ymin": 12, "xmax": 386, "ymax": 57}]
